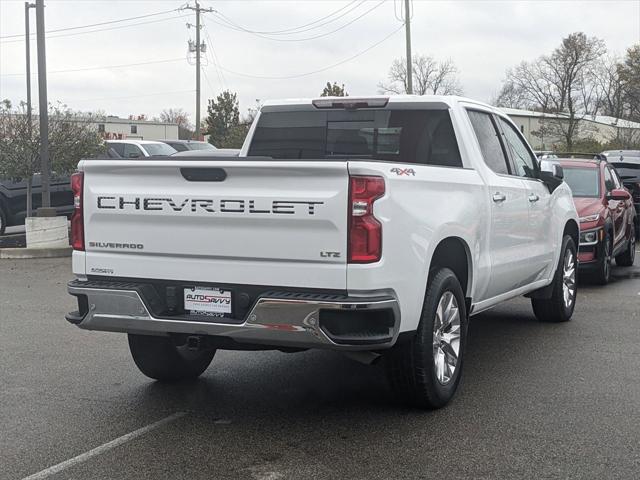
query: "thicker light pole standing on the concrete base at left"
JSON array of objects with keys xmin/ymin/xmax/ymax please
[{"xmin": 36, "ymin": 0, "xmax": 51, "ymax": 211}]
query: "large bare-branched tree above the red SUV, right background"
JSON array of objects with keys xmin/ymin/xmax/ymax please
[{"xmin": 503, "ymin": 32, "xmax": 606, "ymax": 150}]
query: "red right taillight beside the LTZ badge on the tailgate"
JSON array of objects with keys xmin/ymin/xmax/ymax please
[{"xmin": 349, "ymin": 176, "xmax": 384, "ymax": 263}]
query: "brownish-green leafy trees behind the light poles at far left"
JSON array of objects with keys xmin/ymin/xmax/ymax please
[{"xmin": 0, "ymin": 100, "xmax": 104, "ymax": 215}]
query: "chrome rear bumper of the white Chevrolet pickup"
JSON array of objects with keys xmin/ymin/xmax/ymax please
[{"xmin": 66, "ymin": 280, "xmax": 400, "ymax": 350}]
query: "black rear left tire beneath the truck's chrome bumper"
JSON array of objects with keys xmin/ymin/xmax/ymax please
[{"xmin": 129, "ymin": 334, "xmax": 216, "ymax": 382}]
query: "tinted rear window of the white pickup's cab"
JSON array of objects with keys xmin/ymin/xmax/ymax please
[{"xmin": 249, "ymin": 110, "xmax": 462, "ymax": 167}]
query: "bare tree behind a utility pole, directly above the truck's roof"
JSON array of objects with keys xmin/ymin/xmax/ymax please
[{"xmin": 378, "ymin": 55, "xmax": 462, "ymax": 95}]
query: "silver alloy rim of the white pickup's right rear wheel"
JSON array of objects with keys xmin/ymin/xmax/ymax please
[{"xmin": 433, "ymin": 291, "xmax": 460, "ymax": 385}]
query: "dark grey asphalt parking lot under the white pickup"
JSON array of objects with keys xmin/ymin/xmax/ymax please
[{"xmin": 0, "ymin": 258, "xmax": 640, "ymax": 480}]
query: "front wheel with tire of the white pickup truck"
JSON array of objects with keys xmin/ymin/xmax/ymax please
[{"xmin": 531, "ymin": 235, "xmax": 578, "ymax": 323}]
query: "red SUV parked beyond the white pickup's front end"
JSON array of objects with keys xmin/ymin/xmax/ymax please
[{"xmin": 554, "ymin": 158, "xmax": 636, "ymax": 285}]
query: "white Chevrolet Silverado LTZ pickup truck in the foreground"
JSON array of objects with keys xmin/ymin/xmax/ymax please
[{"xmin": 67, "ymin": 96, "xmax": 579, "ymax": 408}]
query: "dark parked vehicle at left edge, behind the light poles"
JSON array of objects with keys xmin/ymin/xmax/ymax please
[{"xmin": 0, "ymin": 175, "xmax": 73, "ymax": 235}]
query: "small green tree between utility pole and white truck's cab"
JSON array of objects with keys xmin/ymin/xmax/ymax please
[{"xmin": 205, "ymin": 90, "xmax": 250, "ymax": 148}]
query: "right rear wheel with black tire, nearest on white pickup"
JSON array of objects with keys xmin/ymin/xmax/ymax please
[{"xmin": 385, "ymin": 268, "xmax": 467, "ymax": 408}]
